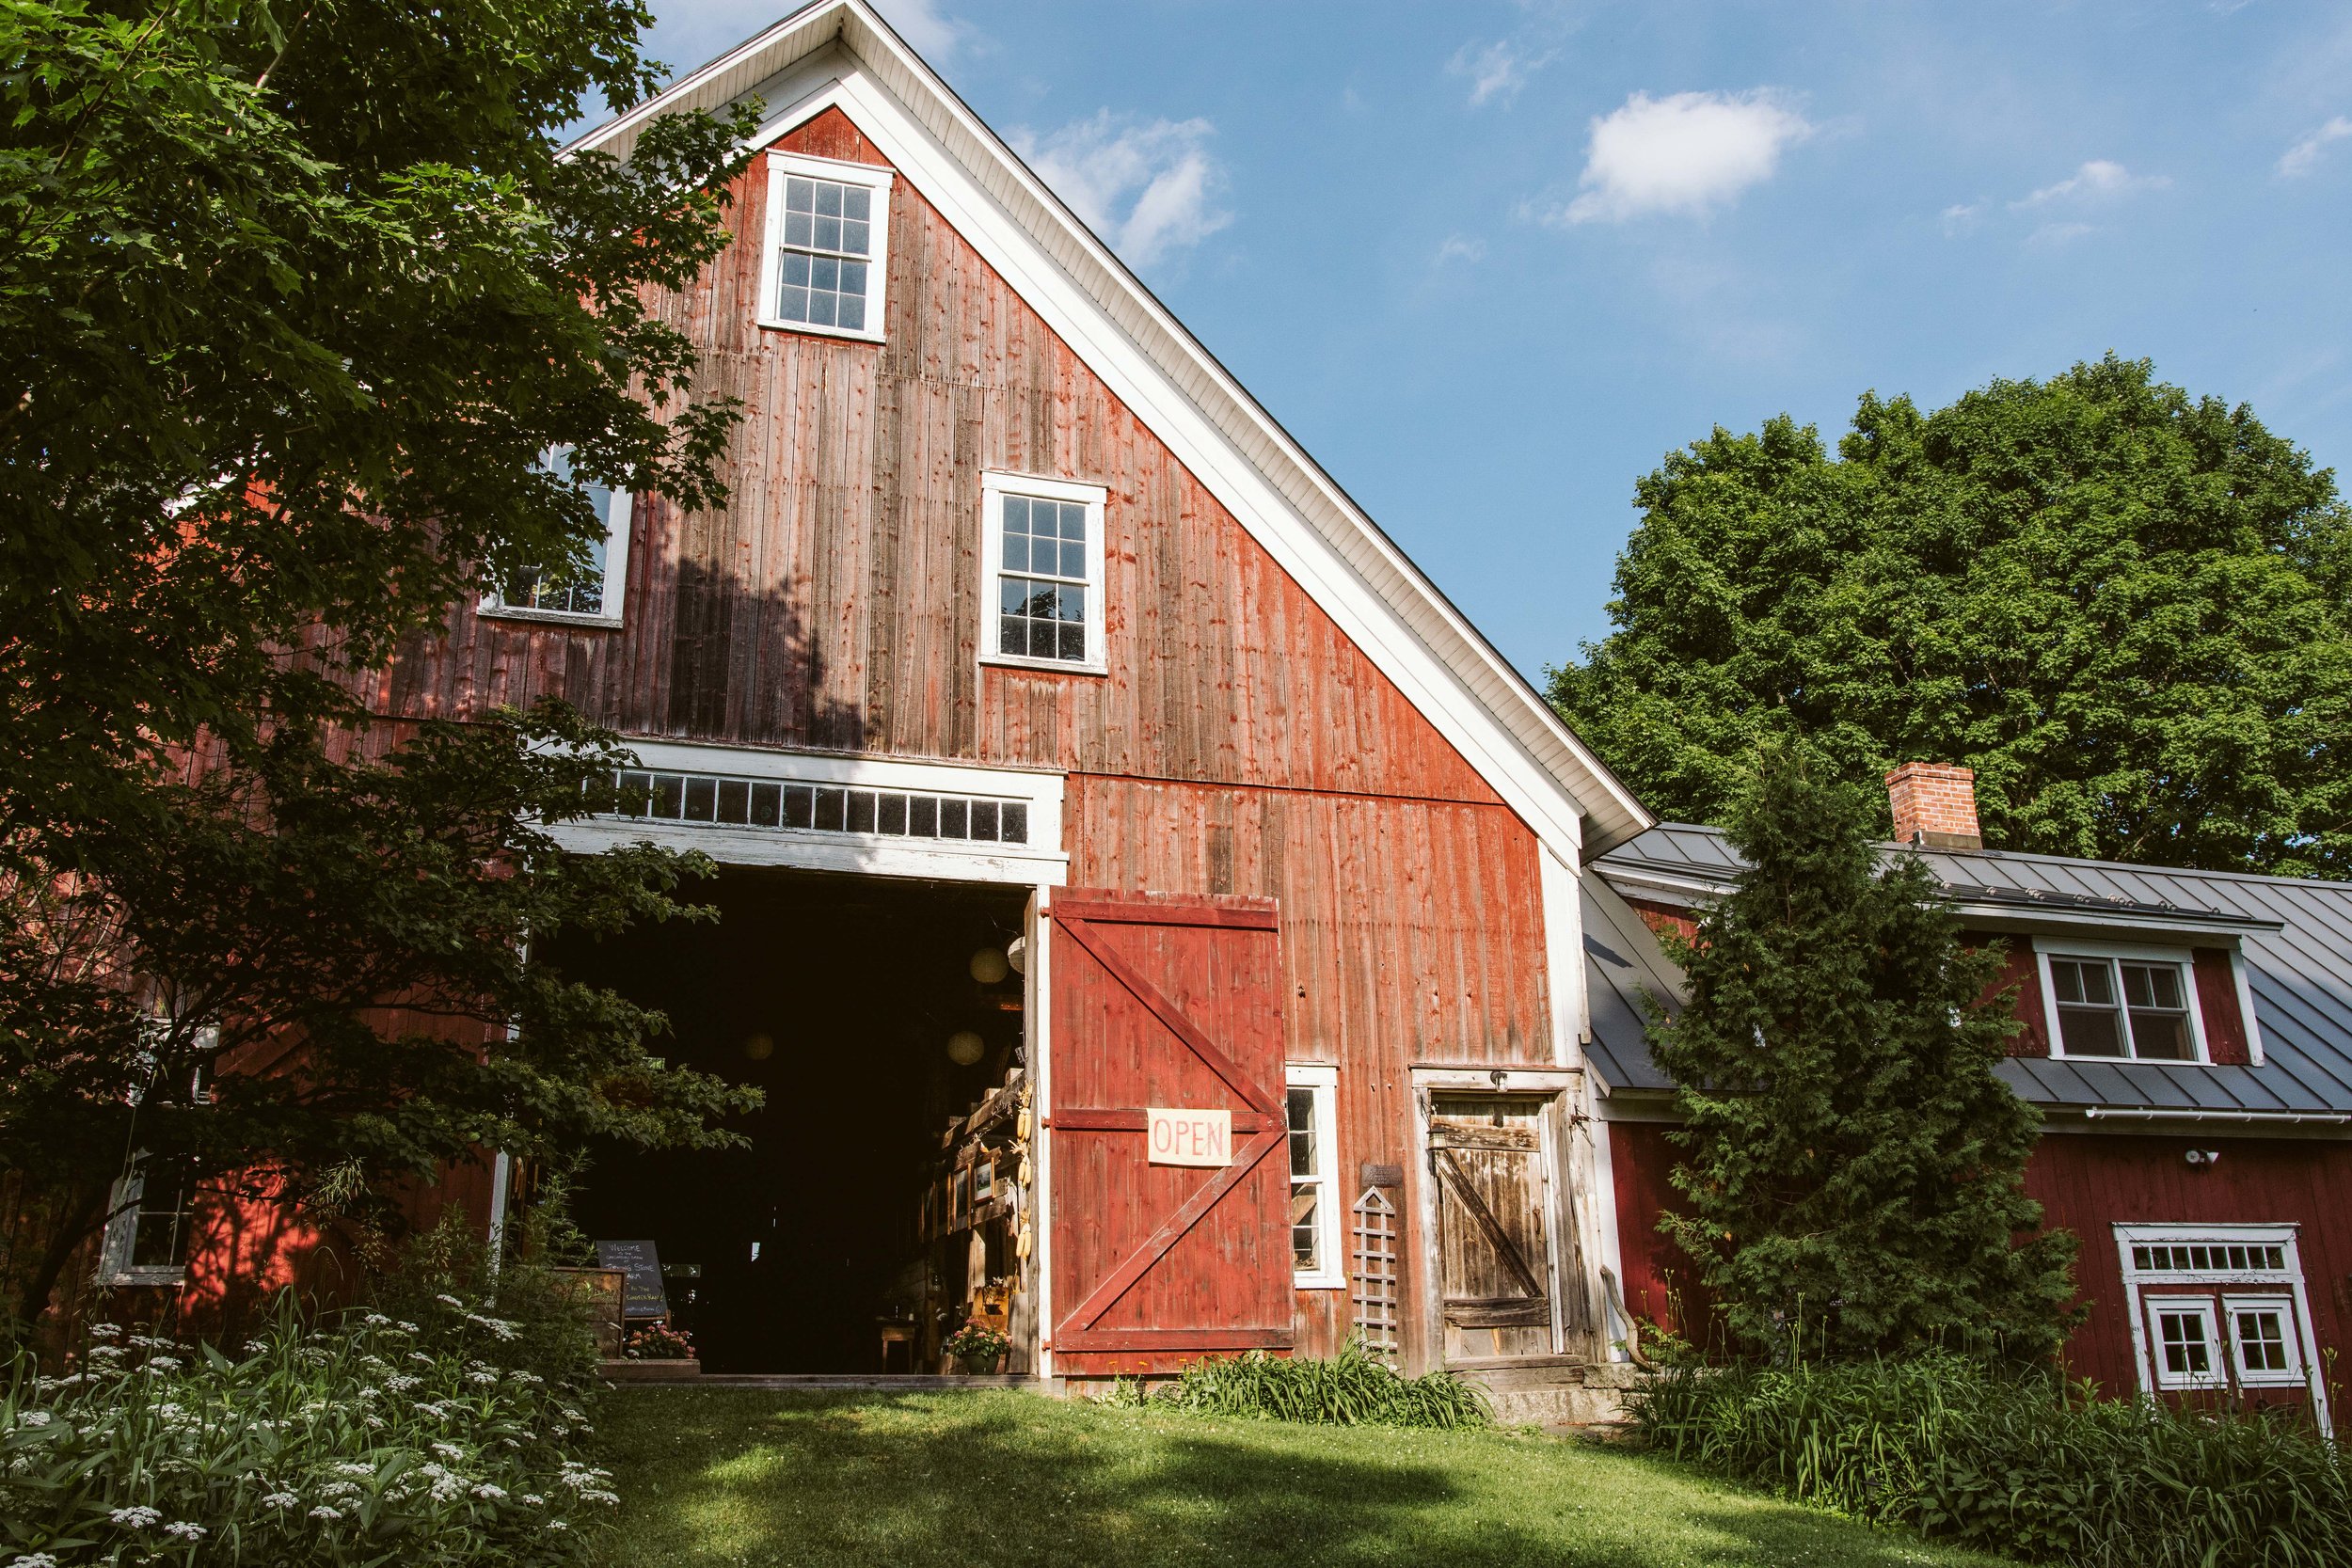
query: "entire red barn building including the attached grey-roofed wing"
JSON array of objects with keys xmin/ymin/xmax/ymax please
[{"xmin": 83, "ymin": 0, "xmax": 2352, "ymax": 1416}]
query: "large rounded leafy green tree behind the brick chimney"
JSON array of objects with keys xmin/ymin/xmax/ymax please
[{"xmin": 1552, "ymin": 357, "xmax": 2352, "ymax": 875}]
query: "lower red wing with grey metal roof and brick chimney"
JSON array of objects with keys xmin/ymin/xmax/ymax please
[{"xmin": 1585, "ymin": 762, "xmax": 2352, "ymax": 1420}]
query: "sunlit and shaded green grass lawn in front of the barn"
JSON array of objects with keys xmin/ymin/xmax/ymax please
[{"xmin": 583, "ymin": 1389, "xmax": 1993, "ymax": 1568}]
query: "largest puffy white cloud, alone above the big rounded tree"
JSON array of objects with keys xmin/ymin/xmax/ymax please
[{"xmin": 1543, "ymin": 89, "xmax": 1814, "ymax": 223}]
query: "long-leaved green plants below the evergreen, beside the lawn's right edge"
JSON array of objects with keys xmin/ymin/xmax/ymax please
[{"xmin": 1632, "ymin": 1352, "xmax": 2352, "ymax": 1568}]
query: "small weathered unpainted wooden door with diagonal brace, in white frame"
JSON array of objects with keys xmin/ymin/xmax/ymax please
[{"xmin": 1430, "ymin": 1093, "xmax": 1552, "ymax": 1361}]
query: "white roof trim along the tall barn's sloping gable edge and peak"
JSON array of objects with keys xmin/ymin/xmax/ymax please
[{"xmin": 572, "ymin": 0, "xmax": 1656, "ymax": 861}]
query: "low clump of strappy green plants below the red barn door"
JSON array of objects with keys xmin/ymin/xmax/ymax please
[{"xmin": 1118, "ymin": 1342, "xmax": 1494, "ymax": 1427}]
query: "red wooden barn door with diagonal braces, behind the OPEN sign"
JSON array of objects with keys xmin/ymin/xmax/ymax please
[{"xmin": 1044, "ymin": 891, "xmax": 1292, "ymax": 1378}]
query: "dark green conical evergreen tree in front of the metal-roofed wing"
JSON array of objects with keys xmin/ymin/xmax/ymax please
[{"xmin": 1654, "ymin": 745, "xmax": 2074, "ymax": 1361}]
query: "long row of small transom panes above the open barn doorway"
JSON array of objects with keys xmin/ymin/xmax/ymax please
[{"xmin": 612, "ymin": 768, "xmax": 1028, "ymax": 844}]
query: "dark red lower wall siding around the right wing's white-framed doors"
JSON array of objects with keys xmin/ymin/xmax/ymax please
[{"xmin": 2026, "ymin": 1133, "xmax": 2352, "ymax": 1394}]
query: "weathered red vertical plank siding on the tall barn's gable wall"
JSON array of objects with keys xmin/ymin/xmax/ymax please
[{"xmin": 379, "ymin": 110, "xmax": 1550, "ymax": 1354}]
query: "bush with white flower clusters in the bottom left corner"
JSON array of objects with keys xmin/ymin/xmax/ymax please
[{"xmin": 0, "ymin": 1293, "xmax": 619, "ymax": 1568}]
